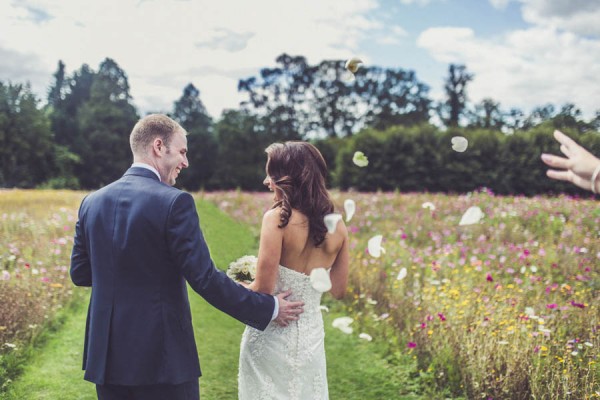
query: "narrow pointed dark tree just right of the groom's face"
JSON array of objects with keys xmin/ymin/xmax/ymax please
[{"xmin": 171, "ymin": 83, "xmax": 218, "ymax": 190}]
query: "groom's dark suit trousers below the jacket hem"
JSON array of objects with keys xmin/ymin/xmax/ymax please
[{"xmin": 96, "ymin": 379, "xmax": 200, "ymax": 400}]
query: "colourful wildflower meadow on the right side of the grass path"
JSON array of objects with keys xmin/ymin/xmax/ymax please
[{"xmin": 202, "ymin": 189, "xmax": 600, "ymax": 399}]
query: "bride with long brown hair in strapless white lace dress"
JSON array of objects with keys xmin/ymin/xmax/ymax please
[{"xmin": 238, "ymin": 142, "xmax": 349, "ymax": 400}]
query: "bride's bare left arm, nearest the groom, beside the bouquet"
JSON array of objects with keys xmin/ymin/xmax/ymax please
[{"xmin": 248, "ymin": 208, "xmax": 283, "ymax": 294}]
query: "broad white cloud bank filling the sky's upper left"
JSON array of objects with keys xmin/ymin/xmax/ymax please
[{"xmin": 0, "ymin": 0, "xmax": 380, "ymax": 116}]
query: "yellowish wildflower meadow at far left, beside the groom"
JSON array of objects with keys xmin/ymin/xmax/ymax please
[{"xmin": 0, "ymin": 190, "xmax": 83, "ymax": 391}]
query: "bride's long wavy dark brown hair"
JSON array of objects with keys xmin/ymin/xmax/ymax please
[{"xmin": 265, "ymin": 142, "xmax": 333, "ymax": 247}]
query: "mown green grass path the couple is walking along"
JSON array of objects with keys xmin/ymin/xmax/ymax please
[{"xmin": 3, "ymin": 202, "xmax": 420, "ymax": 400}]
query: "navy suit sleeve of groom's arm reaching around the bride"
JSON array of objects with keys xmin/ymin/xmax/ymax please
[{"xmin": 167, "ymin": 192, "xmax": 275, "ymax": 330}]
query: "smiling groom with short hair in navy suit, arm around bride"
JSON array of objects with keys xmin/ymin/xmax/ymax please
[{"xmin": 71, "ymin": 114, "xmax": 303, "ymax": 400}]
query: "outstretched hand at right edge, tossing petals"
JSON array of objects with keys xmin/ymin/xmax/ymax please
[{"xmin": 542, "ymin": 130, "xmax": 600, "ymax": 190}]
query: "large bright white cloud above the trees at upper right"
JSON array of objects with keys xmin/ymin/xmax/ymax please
[{"xmin": 417, "ymin": 27, "xmax": 600, "ymax": 117}]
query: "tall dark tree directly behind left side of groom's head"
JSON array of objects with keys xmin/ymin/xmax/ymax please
[{"xmin": 72, "ymin": 58, "xmax": 138, "ymax": 189}]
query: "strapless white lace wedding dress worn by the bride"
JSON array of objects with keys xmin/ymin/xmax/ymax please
[{"xmin": 238, "ymin": 266, "xmax": 329, "ymax": 400}]
